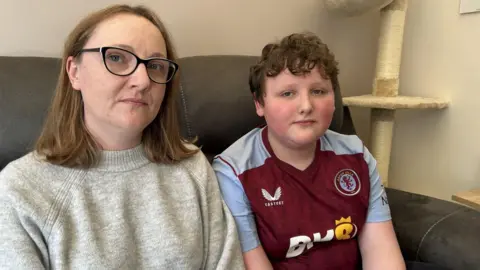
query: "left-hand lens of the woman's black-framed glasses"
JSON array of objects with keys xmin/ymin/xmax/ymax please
[{"xmin": 105, "ymin": 48, "xmax": 137, "ymax": 75}]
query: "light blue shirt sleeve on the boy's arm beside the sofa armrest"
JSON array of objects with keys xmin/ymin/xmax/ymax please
[{"xmin": 364, "ymin": 147, "xmax": 392, "ymax": 222}]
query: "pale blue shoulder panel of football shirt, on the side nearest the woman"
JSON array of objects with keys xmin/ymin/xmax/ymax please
[{"xmin": 213, "ymin": 126, "xmax": 270, "ymax": 175}]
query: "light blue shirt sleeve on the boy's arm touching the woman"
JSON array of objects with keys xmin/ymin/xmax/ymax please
[{"xmin": 212, "ymin": 158, "xmax": 260, "ymax": 252}]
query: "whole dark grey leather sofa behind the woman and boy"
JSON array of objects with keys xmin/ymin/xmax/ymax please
[{"xmin": 0, "ymin": 55, "xmax": 480, "ymax": 270}]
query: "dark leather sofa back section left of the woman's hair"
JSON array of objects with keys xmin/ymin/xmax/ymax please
[{"xmin": 0, "ymin": 56, "xmax": 61, "ymax": 170}]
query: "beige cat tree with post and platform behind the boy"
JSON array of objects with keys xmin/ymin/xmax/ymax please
[{"xmin": 324, "ymin": 0, "xmax": 449, "ymax": 186}]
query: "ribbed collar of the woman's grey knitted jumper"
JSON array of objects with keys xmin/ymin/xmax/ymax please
[{"xmin": 96, "ymin": 144, "xmax": 150, "ymax": 172}]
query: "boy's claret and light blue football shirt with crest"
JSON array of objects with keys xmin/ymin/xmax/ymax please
[{"xmin": 212, "ymin": 126, "xmax": 391, "ymax": 269}]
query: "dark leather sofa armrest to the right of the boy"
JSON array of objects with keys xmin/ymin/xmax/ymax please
[{"xmin": 386, "ymin": 188, "xmax": 480, "ymax": 270}]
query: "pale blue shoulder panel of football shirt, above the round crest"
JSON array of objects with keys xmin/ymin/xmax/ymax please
[{"xmin": 320, "ymin": 130, "xmax": 365, "ymax": 155}]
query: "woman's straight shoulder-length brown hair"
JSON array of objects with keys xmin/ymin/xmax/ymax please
[{"xmin": 35, "ymin": 5, "xmax": 199, "ymax": 168}]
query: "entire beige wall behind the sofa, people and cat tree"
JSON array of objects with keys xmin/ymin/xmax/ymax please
[{"xmin": 0, "ymin": 0, "xmax": 480, "ymax": 199}]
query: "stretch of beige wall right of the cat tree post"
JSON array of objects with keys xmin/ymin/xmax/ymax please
[{"xmin": 391, "ymin": 0, "xmax": 480, "ymax": 199}]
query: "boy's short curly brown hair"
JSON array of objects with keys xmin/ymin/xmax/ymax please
[{"xmin": 249, "ymin": 32, "xmax": 338, "ymax": 105}]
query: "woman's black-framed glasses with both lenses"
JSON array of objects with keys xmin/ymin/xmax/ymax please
[{"xmin": 79, "ymin": 47, "xmax": 178, "ymax": 84}]
